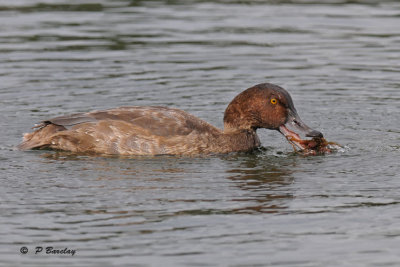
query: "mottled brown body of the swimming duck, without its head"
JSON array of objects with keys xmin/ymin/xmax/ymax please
[{"xmin": 20, "ymin": 107, "xmax": 260, "ymax": 155}]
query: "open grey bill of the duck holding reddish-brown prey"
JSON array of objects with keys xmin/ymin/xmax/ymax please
[{"xmin": 279, "ymin": 112, "xmax": 323, "ymax": 150}]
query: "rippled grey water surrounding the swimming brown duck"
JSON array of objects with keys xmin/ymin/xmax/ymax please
[{"xmin": 0, "ymin": 0, "xmax": 400, "ymax": 266}]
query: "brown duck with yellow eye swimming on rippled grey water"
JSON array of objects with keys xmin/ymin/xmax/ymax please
[{"xmin": 18, "ymin": 83, "xmax": 323, "ymax": 156}]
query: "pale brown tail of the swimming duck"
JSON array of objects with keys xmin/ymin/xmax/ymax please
[{"xmin": 18, "ymin": 124, "xmax": 65, "ymax": 150}]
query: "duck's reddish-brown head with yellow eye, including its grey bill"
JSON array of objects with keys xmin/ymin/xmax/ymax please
[{"xmin": 224, "ymin": 83, "xmax": 323, "ymax": 149}]
